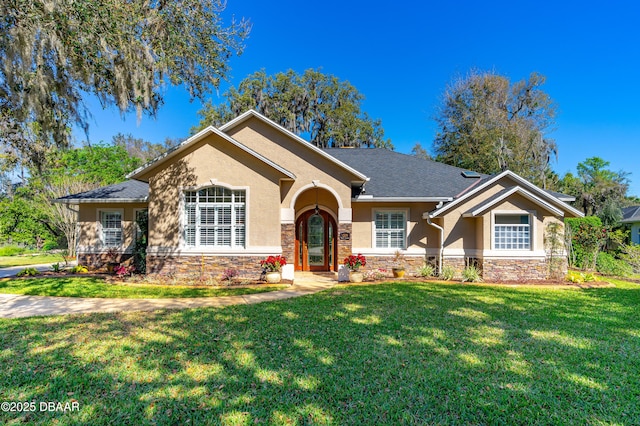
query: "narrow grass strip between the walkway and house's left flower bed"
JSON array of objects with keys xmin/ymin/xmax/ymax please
[{"xmin": 0, "ymin": 276, "xmax": 285, "ymax": 299}]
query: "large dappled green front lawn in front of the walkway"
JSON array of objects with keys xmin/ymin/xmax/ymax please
[{"xmin": 0, "ymin": 281, "xmax": 640, "ymax": 425}]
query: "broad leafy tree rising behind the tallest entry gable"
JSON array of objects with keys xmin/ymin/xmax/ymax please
[{"xmin": 194, "ymin": 69, "xmax": 393, "ymax": 149}]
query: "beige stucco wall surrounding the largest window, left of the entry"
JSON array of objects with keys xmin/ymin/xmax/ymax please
[{"xmin": 149, "ymin": 135, "xmax": 282, "ymax": 247}]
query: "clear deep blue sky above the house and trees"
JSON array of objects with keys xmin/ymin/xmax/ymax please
[{"xmin": 78, "ymin": 0, "xmax": 640, "ymax": 195}]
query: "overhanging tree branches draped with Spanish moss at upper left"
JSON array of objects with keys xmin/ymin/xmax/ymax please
[{"xmin": 0, "ymin": 0, "xmax": 250, "ymax": 168}]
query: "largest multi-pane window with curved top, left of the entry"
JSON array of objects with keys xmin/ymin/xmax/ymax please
[{"xmin": 184, "ymin": 186, "xmax": 246, "ymax": 248}]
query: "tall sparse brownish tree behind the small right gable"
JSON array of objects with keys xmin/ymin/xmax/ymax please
[{"xmin": 433, "ymin": 71, "xmax": 557, "ymax": 187}]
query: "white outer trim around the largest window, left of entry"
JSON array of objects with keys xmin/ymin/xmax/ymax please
[{"xmin": 178, "ymin": 183, "xmax": 252, "ymax": 250}]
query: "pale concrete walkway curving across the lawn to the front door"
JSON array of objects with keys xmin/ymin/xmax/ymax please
[{"xmin": 0, "ymin": 277, "xmax": 337, "ymax": 318}]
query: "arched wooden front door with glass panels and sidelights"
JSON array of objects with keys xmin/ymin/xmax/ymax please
[{"xmin": 295, "ymin": 209, "xmax": 338, "ymax": 271}]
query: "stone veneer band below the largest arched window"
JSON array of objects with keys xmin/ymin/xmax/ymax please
[{"xmin": 147, "ymin": 255, "xmax": 264, "ymax": 280}]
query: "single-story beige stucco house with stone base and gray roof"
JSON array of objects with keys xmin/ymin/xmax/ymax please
[{"xmin": 59, "ymin": 111, "xmax": 582, "ymax": 281}]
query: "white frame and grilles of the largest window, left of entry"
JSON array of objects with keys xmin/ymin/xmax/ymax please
[{"xmin": 180, "ymin": 184, "xmax": 249, "ymax": 251}]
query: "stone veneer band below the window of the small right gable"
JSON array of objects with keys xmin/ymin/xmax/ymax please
[{"xmin": 482, "ymin": 259, "xmax": 552, "ymax": 282}]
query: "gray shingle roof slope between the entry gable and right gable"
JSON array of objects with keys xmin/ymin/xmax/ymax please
[{"xmin": 324, "ymin": 148, "xmax": 488, "ymax": 198}]
